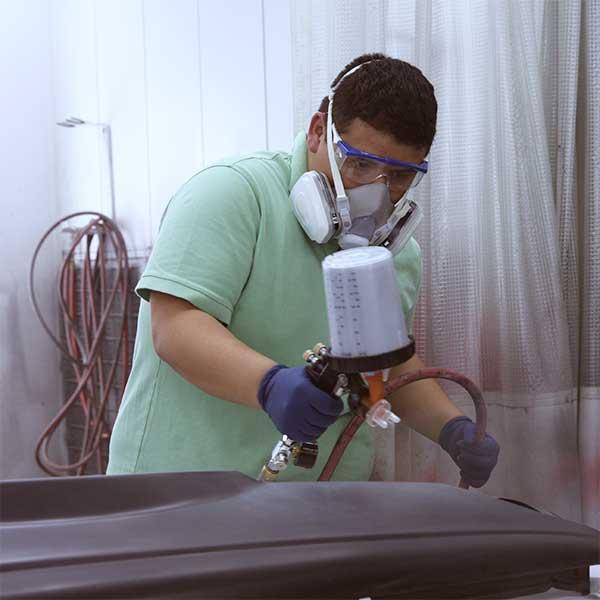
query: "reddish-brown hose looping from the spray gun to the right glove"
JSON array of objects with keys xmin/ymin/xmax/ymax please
[{"xmin": 319, "ymin": 367, "xmax": 487, "ymax": 489}]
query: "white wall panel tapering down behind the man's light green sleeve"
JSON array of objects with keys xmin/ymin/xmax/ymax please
[{"xmin": 144, "ymin": 0, "xmax": 202, "ymax": 239}]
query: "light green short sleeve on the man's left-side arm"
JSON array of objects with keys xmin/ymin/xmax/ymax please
[{"xmin": 136, "ymin": 166, "xmax": 260, "ymax": 325}]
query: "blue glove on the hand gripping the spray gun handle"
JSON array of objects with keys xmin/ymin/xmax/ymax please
[{"xmin": 258, "ymin": 365, "xmax": 344, "ymax": 442}]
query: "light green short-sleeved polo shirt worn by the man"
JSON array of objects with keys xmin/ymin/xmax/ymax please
[{"xmin": 108, "ymin": 134, "xmax": 421, "ymax": 481}]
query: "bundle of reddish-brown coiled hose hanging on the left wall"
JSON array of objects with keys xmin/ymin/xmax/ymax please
[{"xmin": 29, "ymin": 211, "xmax": 129, "ymax": 475}]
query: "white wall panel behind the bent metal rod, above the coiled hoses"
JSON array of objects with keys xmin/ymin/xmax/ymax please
[{"xmin": 51, "ymin": 0, "xmax": 103, "ymax": 214}]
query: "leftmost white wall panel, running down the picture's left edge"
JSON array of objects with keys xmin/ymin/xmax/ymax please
[{"xmin": 0, "ymin": 0, "xmax": 66, "ymax": 479}]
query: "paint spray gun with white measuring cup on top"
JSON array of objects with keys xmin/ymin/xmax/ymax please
[{"xmin": 259, "ymin": 246, "xmax": 415, "ymax": 481}]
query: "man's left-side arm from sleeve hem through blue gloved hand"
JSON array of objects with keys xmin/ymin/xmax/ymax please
[{"xmin": 150, "ymin": 292, "xmax": 343, "ymax": 442}]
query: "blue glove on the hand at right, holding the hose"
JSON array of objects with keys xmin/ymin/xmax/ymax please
[{"xmin": 439, "ymin": 416, "xmax": 500, "ymax": 487}]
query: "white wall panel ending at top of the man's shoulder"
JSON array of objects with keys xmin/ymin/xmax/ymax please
[{"xmin": 198, "ymin": 0, "xmax": 268, "ymax": 163}]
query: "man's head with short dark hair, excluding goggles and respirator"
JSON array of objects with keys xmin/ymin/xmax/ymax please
[{"xmin": 307, "ymin": 54, "xmax": 437, "ymax": 201}]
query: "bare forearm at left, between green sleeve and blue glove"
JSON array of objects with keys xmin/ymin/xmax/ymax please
[{"xmin": 150, "ymin": 292, "xmax": 275, "ymax": 408}]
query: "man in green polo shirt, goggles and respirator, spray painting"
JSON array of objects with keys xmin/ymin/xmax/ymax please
[{"xmin": 108, "ymin": 54, "xmax": 498, "ymax": 486}]
